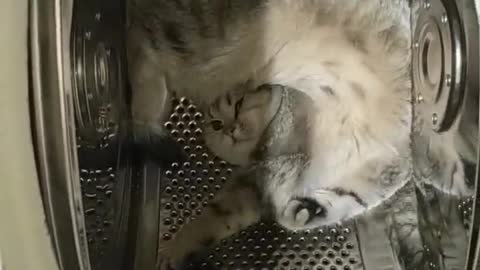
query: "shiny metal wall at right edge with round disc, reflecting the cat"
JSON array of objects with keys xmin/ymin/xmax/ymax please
[{"xmin": 412, "ymin": 0, "xmax": 480, "ymax": 269}]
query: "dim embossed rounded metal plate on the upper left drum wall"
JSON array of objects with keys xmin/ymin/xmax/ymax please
[{"xmin": 71, "ymin": 2, "xmax": 124, "ymax": 140}]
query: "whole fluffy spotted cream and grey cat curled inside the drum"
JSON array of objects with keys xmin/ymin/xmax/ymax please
[{"xmin": 127, "ymin": 0, "xmax": 474, "ymax": 269}]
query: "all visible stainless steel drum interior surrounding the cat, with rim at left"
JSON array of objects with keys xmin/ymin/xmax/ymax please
[{"xmin": 30, "ymin": 0, "xmax": 480, "ymax": 270}]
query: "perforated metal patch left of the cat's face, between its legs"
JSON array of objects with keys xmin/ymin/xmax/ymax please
[{"xmin": 160, "ymin": 98, "xmax": 232, "ymax": 240}]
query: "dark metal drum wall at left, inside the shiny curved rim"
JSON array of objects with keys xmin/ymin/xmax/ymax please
[{"xmin": 70, "ymin": 1, "xmax": 131, "ymax": 269}]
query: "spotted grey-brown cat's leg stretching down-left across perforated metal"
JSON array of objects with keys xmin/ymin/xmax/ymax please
[{"xmin": 158, "ymin": 179, "xmax": 260, "ymax": 270}]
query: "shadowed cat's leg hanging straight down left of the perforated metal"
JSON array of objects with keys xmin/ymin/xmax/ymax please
[{"xmin": 127, "ymin": 26, "xmax": 189, "ymax": 164}]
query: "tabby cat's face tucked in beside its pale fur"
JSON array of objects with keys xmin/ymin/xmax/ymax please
[{"xmin": 204, "ymin": 85, "xmax": 282, "ymax": 165}]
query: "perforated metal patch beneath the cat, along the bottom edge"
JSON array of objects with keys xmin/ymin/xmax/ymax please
[{"xmin": 190, "ymin": 222, "xmax": 363, "ymax": 270}]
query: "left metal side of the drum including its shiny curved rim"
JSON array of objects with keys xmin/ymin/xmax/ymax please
[{"xmin": 30, "ymin": 0, "xmax": 132, "ymax": 270}]
